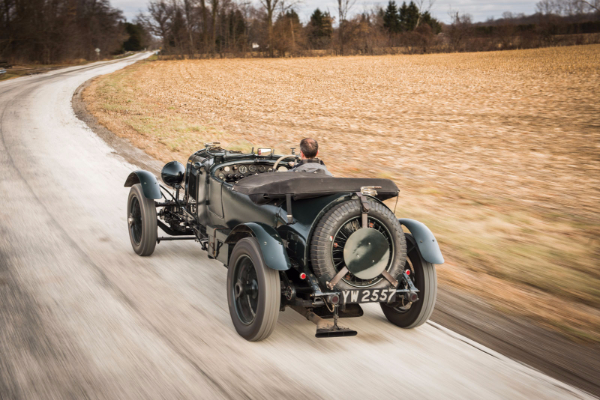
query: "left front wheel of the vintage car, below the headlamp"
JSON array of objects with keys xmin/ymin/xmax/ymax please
[{"xmin": 127, "ymin": 183, "xmax": 158, "ymax": 256}]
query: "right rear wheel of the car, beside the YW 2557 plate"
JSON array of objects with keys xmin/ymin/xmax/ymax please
[{"xmin": 379, "ymin": 233, "xmax": 437, "ymax": 329}]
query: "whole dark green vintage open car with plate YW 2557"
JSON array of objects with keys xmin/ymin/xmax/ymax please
[{"xmin": 125, "ymin": 143, "xmax": 444, "ymax": 341}]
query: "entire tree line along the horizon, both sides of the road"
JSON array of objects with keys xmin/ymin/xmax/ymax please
[{"xmin": 0, "ymin": 0, "xmax": 600, "ymax": 64}]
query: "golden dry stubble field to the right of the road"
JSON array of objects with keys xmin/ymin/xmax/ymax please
[{"xmin": 85, "ymin": 45, "xmax": 600, "ymax": 341}]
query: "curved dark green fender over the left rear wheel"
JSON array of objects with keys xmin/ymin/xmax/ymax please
[{"xmin": 225, "ymin": 222, "xmax": 291, "ymax": 271}]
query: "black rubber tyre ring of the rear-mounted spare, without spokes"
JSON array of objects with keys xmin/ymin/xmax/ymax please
[{"xmin": 311, "ymin": 199, "xmax": 406, "ymax": 290}]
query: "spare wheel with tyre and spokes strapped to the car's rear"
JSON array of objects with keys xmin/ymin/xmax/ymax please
[{"xmin": 310, "ymin": 199, "xmax": 406, "ymax": 290}]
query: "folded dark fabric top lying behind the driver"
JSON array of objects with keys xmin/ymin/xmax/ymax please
[{"xmin": 233, "ymin": 172, "xmax": 399, "ymax": 203}]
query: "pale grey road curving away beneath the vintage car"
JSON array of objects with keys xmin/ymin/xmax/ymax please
[{"xmin": 0, "ymin": 55, "xmax": 589, "ymax": 399}]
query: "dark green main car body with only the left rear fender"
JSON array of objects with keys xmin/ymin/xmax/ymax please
[{"xmin": 185, "ymin": 151, "xmax": 370, "ymax": 274}]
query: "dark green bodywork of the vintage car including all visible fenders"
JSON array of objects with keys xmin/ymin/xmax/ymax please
[{"xmin": 125, "ymin": 148, "xmax": 444, "ymax": 274}]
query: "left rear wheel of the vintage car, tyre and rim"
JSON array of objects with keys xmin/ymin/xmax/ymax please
[{"xmin": 227, "ymin": 237, "xmax": 281, "ymax": 342}]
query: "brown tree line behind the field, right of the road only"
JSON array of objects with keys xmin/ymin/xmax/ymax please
[{"xmin": 139, "ymin": 0, "xmax": 600, "ymax": 57}]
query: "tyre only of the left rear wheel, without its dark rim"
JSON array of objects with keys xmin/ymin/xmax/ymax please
[{"xmin": 227, "ymin": 237, "xmax": 281, "ymax": 341}]
